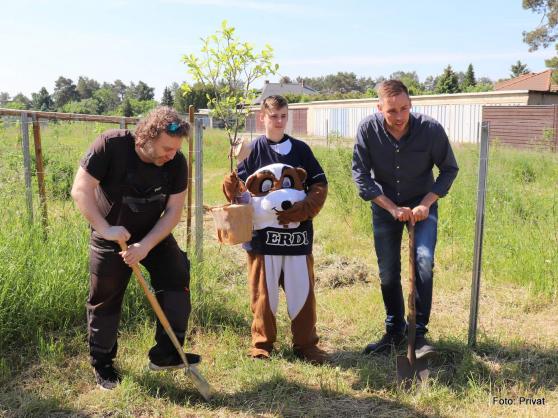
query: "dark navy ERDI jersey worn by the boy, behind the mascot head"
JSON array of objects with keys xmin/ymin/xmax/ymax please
[{"xmin": 238, "ymin": 135, "xmax": 327, "ymax": 255}]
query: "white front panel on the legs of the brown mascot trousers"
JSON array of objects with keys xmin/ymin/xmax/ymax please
[{"xmin": 264, "ymin": 255, "xmax": 310, "ymax": 320}]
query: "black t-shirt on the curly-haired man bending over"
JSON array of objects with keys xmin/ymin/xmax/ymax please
[{"xmin": 80, "ymin": 129, "xmax": 188, "ymax": 242}]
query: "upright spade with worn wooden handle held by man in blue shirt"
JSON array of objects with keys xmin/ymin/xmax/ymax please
[{"xmin": 396, "ymin": 222, "xmax": 430, "ymax": 389}]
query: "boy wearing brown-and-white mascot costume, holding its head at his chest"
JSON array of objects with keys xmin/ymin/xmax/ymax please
[{"xmin": 223, "ymin": 96, "xmax": 328, "ymax": 364}]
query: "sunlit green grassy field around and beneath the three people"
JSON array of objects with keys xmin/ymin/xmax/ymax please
[{"xmin": 0, "ymin": 119, "xmax": 558, "ymax": 417}]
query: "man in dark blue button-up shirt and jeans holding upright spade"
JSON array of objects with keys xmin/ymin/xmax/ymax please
[{"xmin": 352, "ymin": 80, "xmax": 458, "ymax": 358}]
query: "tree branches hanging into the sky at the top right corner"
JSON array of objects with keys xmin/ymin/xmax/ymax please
[{"xmin": 518, "ymin": 0, "xmax": 558, "ymax": 83}]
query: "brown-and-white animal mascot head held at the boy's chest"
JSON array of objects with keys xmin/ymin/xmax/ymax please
[{"xmin": 246, "ymin": 163, "xmax": 306, "ymax": 230}]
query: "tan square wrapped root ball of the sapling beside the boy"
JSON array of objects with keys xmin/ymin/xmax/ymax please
[{"xmin": 211, "ymin": 204, "xmax": 253, "ymax": 245}]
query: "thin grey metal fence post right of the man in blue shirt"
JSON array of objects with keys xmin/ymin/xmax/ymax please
[{"xmin": 468, "ymin": 122, "xmax": 490, "ymax": 347}]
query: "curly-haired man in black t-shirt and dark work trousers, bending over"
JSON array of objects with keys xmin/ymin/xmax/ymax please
[{"xmin": 72, "ymin": 107, "xmax": 200, "ymax": 389}]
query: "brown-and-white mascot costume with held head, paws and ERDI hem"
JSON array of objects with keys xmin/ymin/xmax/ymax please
[{"xmin": 223, "ymin": 160, "xmax": 327, "ymax": 364}]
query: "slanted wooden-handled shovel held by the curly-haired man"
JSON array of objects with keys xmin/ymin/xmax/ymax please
[{"xmin": 118, "ymin": 242, "xmax": 213, "ymax": 401}]
